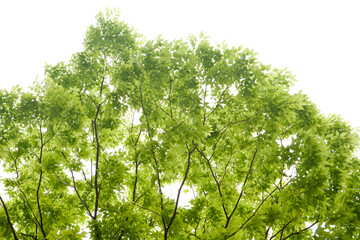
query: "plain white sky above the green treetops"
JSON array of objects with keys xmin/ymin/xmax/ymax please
[{"xmin": 0, "ymin": 0, "xmax": 360, "ymax": 127}]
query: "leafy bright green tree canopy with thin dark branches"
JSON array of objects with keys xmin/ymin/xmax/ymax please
[{"xmin": 0, "ymin": 12, "xmax": 360, "ymax": 240}]
